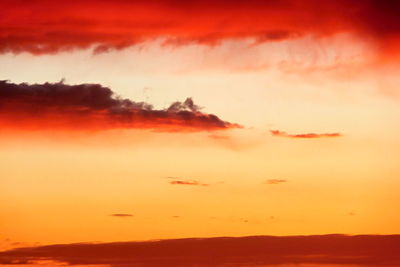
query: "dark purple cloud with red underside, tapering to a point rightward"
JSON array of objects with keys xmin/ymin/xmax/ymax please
[{"xmin": 0, "ymin": 81, "xmax": 240, "ymax": 132}]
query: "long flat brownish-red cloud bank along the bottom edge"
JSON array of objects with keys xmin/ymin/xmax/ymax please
[{"xmin": 0, "ymin": 235, "xmax": 400, "ymax": 267}]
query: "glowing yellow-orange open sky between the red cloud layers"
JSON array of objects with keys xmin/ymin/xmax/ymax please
[{"xmin": 0, "ymin": 35, "xmax": 400, "ymax": 249}]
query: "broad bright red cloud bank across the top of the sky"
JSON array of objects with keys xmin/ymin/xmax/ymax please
[{"xmin": 0, "ymin": 0, "xmax": 400, "ymax": 59}]
